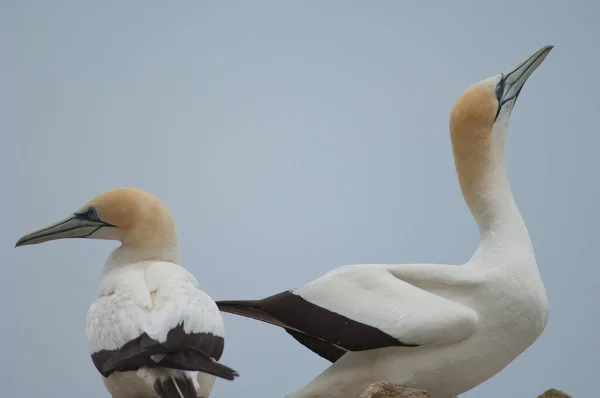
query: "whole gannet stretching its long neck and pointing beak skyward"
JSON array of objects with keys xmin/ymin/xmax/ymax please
[{"xmin": 217, "ymin": 46, "xmax": 552, "ymax": 398}]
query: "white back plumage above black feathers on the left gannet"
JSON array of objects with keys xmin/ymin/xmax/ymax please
[{"xmin": 86, "ymin": 261, "xmax": 224, "ymax": 353}]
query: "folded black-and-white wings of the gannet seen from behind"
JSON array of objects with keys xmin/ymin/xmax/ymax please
[{"xmin": 86, "ymin": 262, "xmax": 237, "ymax": 380}]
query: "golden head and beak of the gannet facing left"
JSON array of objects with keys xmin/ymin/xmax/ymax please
[{"xmin": 16, "ymin": 188, "xmax": 177, "ymax": 247}]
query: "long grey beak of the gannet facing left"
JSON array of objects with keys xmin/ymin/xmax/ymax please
[{"xmin": 15, "ymin": 214, "xmax": 110, "ymax": 247}]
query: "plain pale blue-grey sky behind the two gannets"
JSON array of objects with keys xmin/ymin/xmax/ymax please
[{"xmin": 0, "ymin": 0, "xmax": 600, "ymax": 398}]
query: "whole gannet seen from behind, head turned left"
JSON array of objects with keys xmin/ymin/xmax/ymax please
[{"xmin": 16, "ymin": 188, "xmax": 237, "ymax": 398}]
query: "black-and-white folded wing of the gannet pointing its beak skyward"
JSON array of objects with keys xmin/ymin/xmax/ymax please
[{"xmin": 217, "ymin": 265, "xmax": 478, "ymax": 362}]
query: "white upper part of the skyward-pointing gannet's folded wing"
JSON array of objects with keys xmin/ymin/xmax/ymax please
[{"xmin": 293, "ymin": 264, "xmax": 478, "ymax": 345}]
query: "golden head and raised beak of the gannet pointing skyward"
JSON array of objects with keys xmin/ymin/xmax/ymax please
[{"xmin": 450, "ymin": 46, "xmax": 553, "ymax": 207}]
